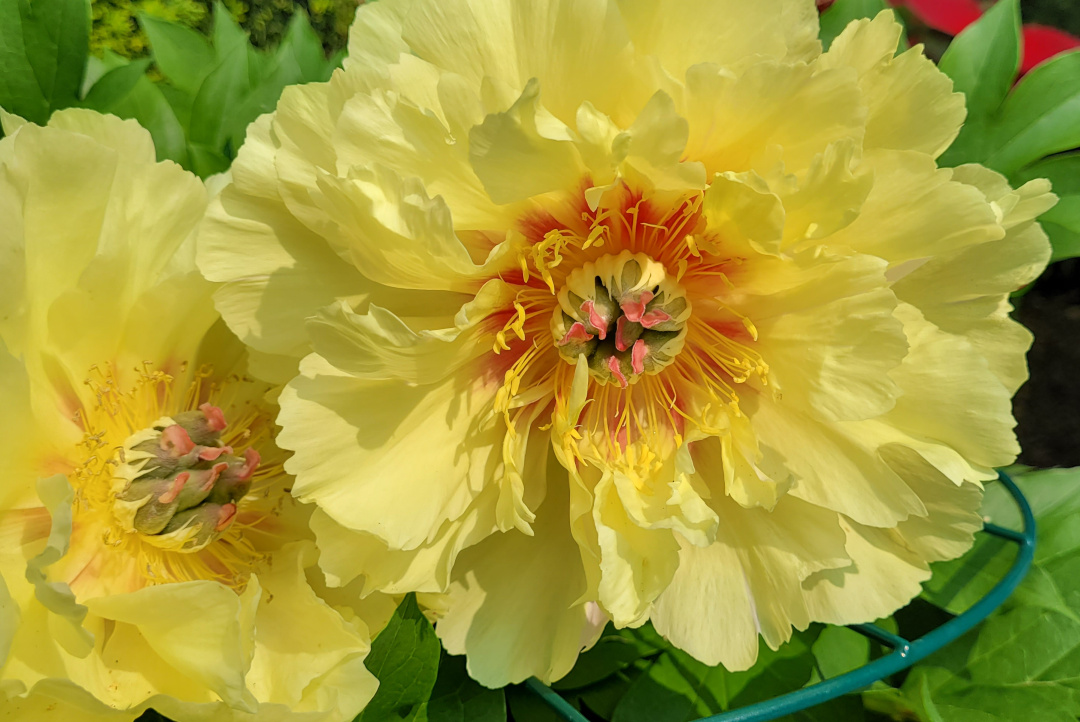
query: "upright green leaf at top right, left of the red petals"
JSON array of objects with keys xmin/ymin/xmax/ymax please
[{"xmin": 939, "ymin": 0, "xmax": 1021, "ymax": 119}]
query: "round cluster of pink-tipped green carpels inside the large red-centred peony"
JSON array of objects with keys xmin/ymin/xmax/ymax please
[{"xmin": 551, "ymin": 250, "xmax": 690, "ymax": 387}]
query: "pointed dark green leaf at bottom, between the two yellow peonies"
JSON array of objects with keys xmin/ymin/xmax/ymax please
[{"xmin": 356, "ymin": 595, "xmax": 440, "ymax": 722}]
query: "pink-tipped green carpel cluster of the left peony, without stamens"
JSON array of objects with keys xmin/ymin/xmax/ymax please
[{"xmin": 112, "ymin": 404, "xmax": 259, "ymax": 553}]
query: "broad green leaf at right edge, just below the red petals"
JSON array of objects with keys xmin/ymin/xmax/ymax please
[{"xmin": 975, "ymin": 51, "xmax": 1080, "ymax": 176}]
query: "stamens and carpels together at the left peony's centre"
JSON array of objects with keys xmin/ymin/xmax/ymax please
[{"xmin": 65, "ymin": 364, "xmax": 285, "ymax": 595}]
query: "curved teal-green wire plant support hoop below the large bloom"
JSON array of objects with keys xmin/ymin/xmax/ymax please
[{"xmin": 525, "ymin": 472, "xmax": 1035, "ymax": 722}]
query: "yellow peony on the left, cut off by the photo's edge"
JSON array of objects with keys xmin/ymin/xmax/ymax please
[{"xmin": 0, "ymin": 110, "xmax": 386, "ymax": 722}]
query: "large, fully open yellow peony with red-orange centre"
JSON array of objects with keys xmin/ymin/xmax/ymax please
[{"xmin": 199, "ymin": 0, "xmax": 1053, "ymax": 685}]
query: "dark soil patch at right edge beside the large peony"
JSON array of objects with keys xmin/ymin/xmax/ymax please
[{"xmin": 1014, "ymin": 259, "xmax": 1080, "ymax": 467}]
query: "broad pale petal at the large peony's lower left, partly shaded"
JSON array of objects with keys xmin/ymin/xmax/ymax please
[{"xmin": 278, "ymin": 356, "xmax": 505, "ymax": 549}]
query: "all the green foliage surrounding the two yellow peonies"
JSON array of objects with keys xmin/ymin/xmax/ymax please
[{"xmin": 0, "ymin": 0, "xmax": 1080, "ymax": 722}]
